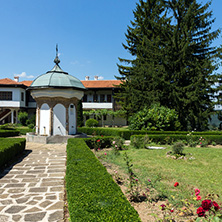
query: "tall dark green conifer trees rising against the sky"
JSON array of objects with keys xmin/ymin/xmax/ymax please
[{"xmin": 116, "ymin": 0, "xmax": 221, "ymax": 130}]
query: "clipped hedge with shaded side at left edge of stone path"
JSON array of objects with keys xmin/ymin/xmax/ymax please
[{"xmin": 0, "ymin": 138, "xmax": 26, "ymax": 167}]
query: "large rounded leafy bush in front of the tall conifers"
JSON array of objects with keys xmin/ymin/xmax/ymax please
[{"xmin": 129, "ymin": 104, "xmax": 180, "ymax": 130}]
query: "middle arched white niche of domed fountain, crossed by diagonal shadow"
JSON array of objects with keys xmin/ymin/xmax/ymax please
[{"xmin": 53, "ymin": 104, "xmax": 66, "ymax": 136}]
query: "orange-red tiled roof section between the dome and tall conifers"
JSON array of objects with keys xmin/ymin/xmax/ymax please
[{"xmin": 81, "ymin": 80, "xmax": 121, "ymax": 88}]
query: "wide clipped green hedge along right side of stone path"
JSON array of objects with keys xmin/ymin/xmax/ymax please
[{"xmin": 66, "ymin": 138, "xmax": 141, "ymax": 222}]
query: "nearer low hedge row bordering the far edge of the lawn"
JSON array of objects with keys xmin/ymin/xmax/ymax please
[{"xmin": 130, "ymin": 134, "xmax": 222, "ymax": 145}]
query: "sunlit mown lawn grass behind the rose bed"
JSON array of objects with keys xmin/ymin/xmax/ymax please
[{"xmin": 102, "ymin": 147, "xmax": 222, "ymax": 206}]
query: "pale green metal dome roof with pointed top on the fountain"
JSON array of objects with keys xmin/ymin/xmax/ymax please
[{"xmin": 29, "ymin": 50, "xmax": 85, "ymax": 90}]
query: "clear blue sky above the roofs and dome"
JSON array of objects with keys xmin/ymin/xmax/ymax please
[{"xmin": 0, "ymin": 0, "xmax": 222, "ymax": 81}]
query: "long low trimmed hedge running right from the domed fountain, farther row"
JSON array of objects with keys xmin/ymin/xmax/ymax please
[{"xmin": 78, "ymin": 127, "xmax": 222, "ymax": 140}]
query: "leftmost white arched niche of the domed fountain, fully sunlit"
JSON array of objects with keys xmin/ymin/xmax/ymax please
[{"xmin": 38, "ymin": 103, "xmax": 50, "ymax": 135}]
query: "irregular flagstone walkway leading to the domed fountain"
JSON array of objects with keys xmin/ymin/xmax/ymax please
[{"xmin": 0, "ymin": 142, "xmax": 66, "ymax": 222}]
